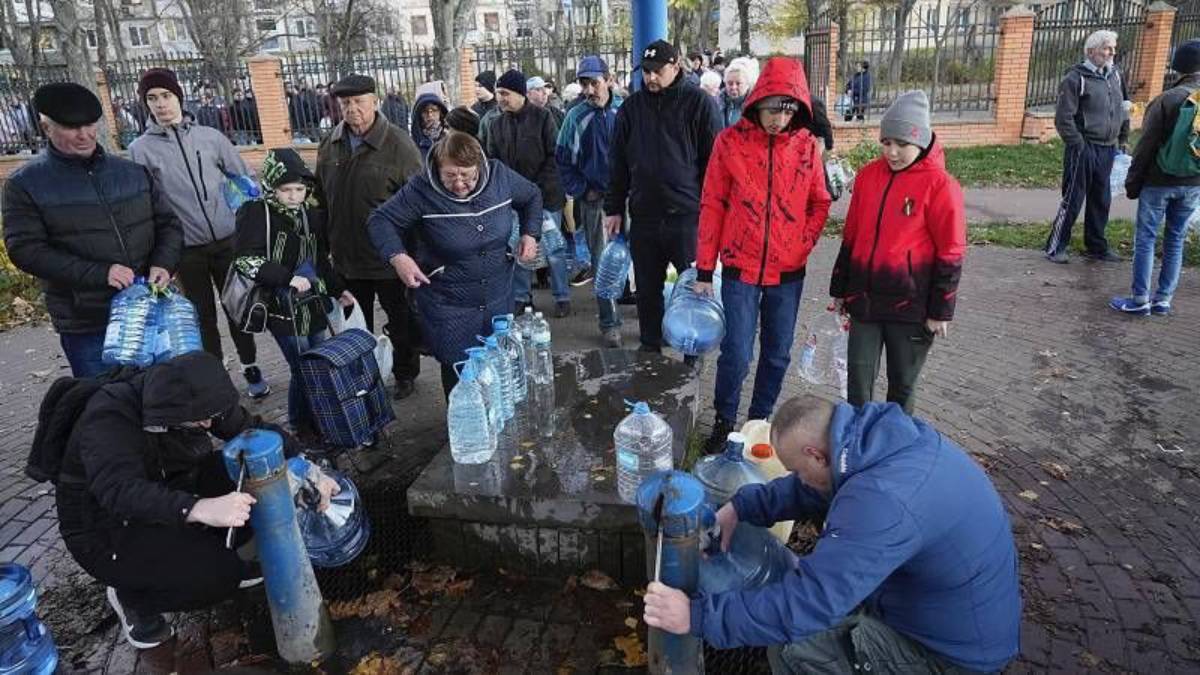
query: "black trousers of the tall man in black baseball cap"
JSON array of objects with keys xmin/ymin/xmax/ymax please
[{"xmin": 629, "ymin": 214, "xmax": 700, "ymax": 347}]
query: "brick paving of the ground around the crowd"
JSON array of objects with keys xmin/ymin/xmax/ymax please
[{"xmin": 0, "ymin": 240, "xmax": 1200, "ymax": 673}]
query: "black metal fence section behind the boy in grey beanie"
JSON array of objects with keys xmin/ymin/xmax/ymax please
[{"xmin": 835, "ymin": 1, "xmax": 1002, "ymax": 120}]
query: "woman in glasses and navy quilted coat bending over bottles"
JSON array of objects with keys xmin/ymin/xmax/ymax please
[{"xmin": 367, "ymin": 131, "xmax": 541, "ymax": 396}]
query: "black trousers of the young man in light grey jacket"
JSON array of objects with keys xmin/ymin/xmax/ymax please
[{"xmin": 176, "ymin": 237, "xmax": 257, "ymax": 364}]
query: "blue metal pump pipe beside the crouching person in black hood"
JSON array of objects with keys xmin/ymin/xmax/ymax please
[{"xmin": 224, "ymin": 429, "xmax": 334, "ymax": 663}]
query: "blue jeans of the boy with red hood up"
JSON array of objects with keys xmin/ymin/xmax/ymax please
[{"xmin": 713, "ymin": 277, "xmax": 804, "ymax": 422}]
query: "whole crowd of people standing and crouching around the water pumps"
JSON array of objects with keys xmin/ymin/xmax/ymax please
[{"xmin": 4, "ymin": 26, "xmax": 1200, "ymax": 673}]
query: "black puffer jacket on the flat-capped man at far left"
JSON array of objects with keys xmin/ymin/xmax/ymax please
[{"xmin": 4, "ymin": 148, "xmax": 184, "ymax": 333}]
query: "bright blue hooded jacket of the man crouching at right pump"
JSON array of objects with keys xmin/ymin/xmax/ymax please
[{"xmin": 691, "ymin": 404, "xmax": 1021, "ymax": 671}]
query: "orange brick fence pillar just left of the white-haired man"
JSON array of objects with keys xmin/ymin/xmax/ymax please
[{"xmin": 992, "ymin": 5, "xmax": 1034, "ymax": 144}]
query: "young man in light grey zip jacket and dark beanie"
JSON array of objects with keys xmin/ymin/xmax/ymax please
[{"xmin": 130, "ymin": 68, "xmax": 271, "ymax": 399}]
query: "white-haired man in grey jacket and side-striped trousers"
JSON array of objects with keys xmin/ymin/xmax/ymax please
[{"xmin": 1045, "ymin": 30, "xmax": 1132, "ymax": 263}]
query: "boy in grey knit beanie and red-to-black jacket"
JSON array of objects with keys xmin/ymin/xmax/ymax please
[{"xmin": 829, "ymin": 91, "xmax": 967, "ymax": 414}]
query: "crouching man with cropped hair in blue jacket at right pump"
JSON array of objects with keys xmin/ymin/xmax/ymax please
[{"xmin": 644, "ymin": 395, "xmax": 1021, "ymax": 673}]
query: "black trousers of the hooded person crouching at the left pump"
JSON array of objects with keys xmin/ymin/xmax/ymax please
[{"xmin": 66, "ymin": 452, "xmax": 260, "ymax": 613}]
